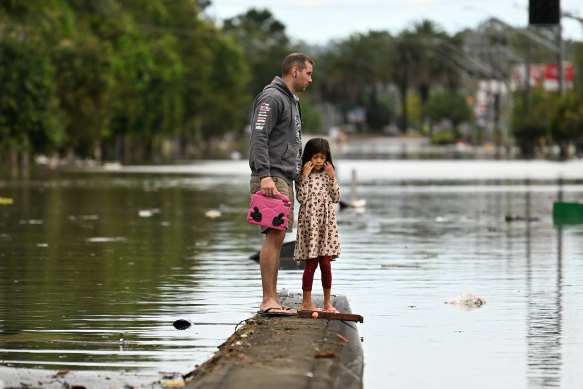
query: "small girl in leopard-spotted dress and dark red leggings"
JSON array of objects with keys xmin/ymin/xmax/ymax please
[{"xmin": 294, "ymin": 138, "xmax": 340, "ymax": 313}]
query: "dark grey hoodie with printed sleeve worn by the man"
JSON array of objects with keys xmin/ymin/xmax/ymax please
[{"xmin": 249, "ymin": 77, "xmax": 302, "ymax": 185}]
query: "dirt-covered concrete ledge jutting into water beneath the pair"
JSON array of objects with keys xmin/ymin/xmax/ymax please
[{"xmin": 184, "ymin": 291, "xmax": 364, "ymax": 389}]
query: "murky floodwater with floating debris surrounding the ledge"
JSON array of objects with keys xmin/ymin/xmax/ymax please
[{"xmin": 0, "ymin": 160, "xmax": 583, "ymax": 389}]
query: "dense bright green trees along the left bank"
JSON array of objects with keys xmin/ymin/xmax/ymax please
[{"xmin": 0, "ymin": 0, "xmax": 249, "ymax": 158}]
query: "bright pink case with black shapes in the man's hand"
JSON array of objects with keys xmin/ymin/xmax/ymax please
[{"xmin": 247, "ymin": 191, "xmax": 291, "ymax": 230}]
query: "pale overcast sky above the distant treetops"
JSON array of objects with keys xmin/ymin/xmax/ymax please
[{"xmin": 206, "ymin": 0, "xmax": 583, "ymax": 44}]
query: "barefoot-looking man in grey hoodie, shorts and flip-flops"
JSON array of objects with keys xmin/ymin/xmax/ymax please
[{"xmin": 249, "ymin": 53, "xmax": 314, "ymax": 315}]
